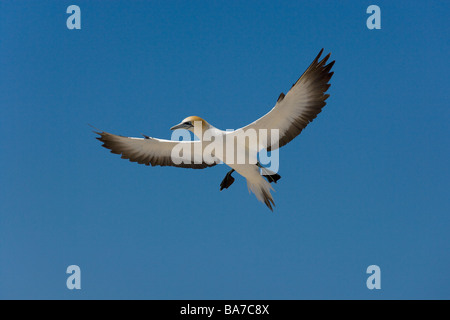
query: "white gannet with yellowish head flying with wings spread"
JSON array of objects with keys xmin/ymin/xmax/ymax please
[{"xmin": 94, "ymin": 49, "xmax": 334, "ymax": 211}]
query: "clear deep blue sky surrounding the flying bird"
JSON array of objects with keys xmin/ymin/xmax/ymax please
[{"xmin": 0, "ymin": 1, "xmax": 450, "ymax": 299}]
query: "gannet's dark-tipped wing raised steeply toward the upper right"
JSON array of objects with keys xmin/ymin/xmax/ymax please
[{"xmin": 239, "ymin": 49, "xmax": 334, "ymax": 151}]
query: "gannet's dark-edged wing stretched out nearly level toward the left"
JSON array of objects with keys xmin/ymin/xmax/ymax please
[{"xmin": 94, "ymin": 131, "xmax": 219, "ymax": 169}]
